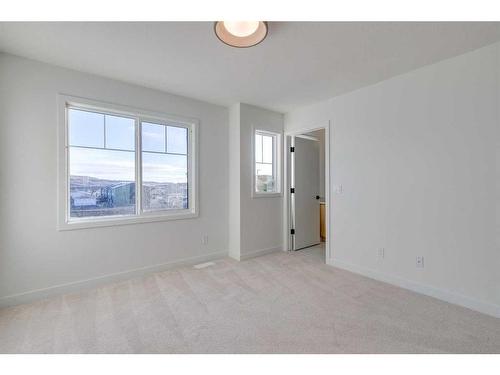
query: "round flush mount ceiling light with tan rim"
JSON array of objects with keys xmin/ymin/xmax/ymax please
[{"xmin": 214, "ymin": 21, "xmax": 267, "ymax": 48}]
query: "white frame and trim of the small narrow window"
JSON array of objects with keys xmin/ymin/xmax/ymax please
[{"xmin": 252, "ymin": 129, "xmax": 282, "ymax": 198}]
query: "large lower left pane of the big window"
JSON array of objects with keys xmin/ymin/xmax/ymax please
[{"xmin": 69, "ymin": 147, "xmax": 135, "ymax": 218}]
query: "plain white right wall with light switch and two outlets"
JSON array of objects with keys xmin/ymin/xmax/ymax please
[{"xmin": 285, "ymin": 44, "xmax": 500, "ymax": 316}]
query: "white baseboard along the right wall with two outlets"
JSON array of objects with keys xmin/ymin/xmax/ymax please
[{"xmin": 326, "ymin": 259, "xmax": 500, "ymax": 318}]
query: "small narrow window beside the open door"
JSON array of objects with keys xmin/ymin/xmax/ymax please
[{"xmin": 253, "ymin": 130, "xmax": 280, "ymax": 195}]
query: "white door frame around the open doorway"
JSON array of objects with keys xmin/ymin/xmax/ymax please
[{"xmin": 283, "ymin": 121, "xmax": 332, "ymax": 264}]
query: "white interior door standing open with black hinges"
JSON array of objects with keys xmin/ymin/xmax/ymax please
[{"xmin": 291, "ymin": 137, "xmax": 321, "ymax": 250}]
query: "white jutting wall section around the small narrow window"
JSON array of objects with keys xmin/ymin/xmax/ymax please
[{"xmin": 229, "ymin": 103, "xmax": 283, "ymax": 260}]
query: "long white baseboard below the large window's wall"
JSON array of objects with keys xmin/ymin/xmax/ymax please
[{"xmin": 0, "ymin": 251, "xmax": 227, "ymax": 308}]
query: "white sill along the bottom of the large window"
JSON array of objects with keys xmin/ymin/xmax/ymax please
[{"xmin": 57, "ymin": 211, "xmax": 198, "ymax": 231}]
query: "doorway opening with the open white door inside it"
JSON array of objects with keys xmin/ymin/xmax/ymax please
[{"xmin": 284, "ymin": 124, "xmax": 331, "ymax": 263}]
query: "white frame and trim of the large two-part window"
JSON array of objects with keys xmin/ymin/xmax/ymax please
[{"xmin": 57, "ymin": 95, "xmax": 199, "ymax": 230}]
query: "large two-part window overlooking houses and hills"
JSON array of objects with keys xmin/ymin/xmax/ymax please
[{"xmin": 60, "ymin": 100, "xmax": 197, "ymax": 229}]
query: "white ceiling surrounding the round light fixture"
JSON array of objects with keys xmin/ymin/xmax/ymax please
[{"xmin": 0, "ymin": 22, "xmax": 500, "ymax": 112}]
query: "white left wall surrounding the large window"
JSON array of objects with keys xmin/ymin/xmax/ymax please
[{"xmin": 0, "ymin": 54, "xmax": 229, "ymax": 304}]
